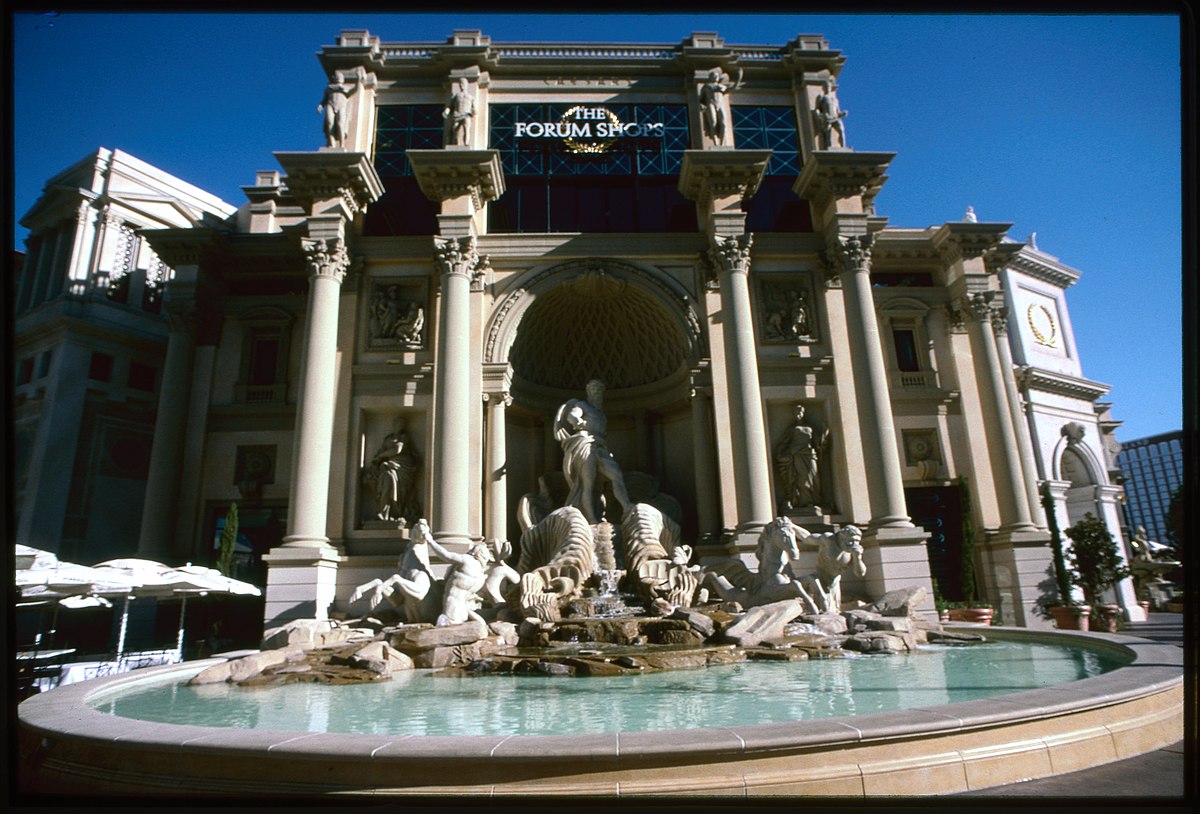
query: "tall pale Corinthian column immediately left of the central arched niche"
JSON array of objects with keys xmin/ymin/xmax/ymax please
[{"xmin": 432, "ymin": 237, "xmax": 480, "ymax": 544}]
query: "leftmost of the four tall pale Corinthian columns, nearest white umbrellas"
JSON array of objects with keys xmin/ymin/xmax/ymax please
[{"xmin": 283, "ymin": 238, "xmax": 349, "ymax": 547}]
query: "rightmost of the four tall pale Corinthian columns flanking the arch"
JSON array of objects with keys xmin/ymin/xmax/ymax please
[{"xmin": 834, "ymin": 234, "xmax": 912, "ymax": 528}]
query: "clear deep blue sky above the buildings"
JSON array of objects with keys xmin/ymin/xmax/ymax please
[{"xmin": 13, "ymin": 12, "xmax": 1182, "ymax": 441}]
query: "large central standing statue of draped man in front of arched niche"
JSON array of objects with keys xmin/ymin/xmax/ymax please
[{"xmin": 554, "ymin": 378, "xmax": 630, "ymax": 523}]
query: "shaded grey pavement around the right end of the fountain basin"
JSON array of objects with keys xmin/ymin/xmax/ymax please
[{"xmin": 955, "ymin": 614, "xmax": 1196, "ymax": 810}]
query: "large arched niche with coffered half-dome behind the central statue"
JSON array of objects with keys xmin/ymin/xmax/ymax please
[{"xmin": 484, "ymin": 259, "xmax": 704, "ymax": 539}]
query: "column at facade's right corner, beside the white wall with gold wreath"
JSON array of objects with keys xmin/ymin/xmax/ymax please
[{"xmin": 967, "ymin": 292, "xmax": 1036, "ymax": 531}]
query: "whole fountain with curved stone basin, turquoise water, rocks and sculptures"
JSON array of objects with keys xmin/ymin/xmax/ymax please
[{"xmin": 19, "ymin": 388, "xmax": 1183, "ymax": 797}]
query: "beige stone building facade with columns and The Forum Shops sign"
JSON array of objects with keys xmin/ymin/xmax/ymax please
[{"xmin": 21, "ymin": 31, "xmax": 1140, "ymax": 626}]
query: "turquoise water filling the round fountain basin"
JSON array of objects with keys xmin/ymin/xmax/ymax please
[{"xmin": 89, "ymin": 640, "xmax": 1128, "ymax": 735}]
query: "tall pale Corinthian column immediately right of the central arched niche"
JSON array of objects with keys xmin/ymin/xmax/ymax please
[{"xmin": 710, "ymin": 234, "xmax": 772, "ymax": 532}]
